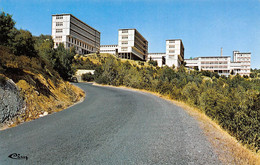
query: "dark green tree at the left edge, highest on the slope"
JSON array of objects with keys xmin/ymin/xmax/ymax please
[{"xmin": 0, "ymin": 12, "xmax": 16, "ymax": 46}]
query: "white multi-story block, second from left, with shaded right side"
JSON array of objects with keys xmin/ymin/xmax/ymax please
[{"xmin": 118, "ymin": 29, "xmax": 148, "ymax": 61}]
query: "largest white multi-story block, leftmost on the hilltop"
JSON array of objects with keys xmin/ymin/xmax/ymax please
[{"xmin": 52, "ymin": 14, "xmax": 100, "ymax": 54}]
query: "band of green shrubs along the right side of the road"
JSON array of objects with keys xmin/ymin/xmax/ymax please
[{"xmin": 74, "ymin": 56, "xmax": 260, "ymax": 151}]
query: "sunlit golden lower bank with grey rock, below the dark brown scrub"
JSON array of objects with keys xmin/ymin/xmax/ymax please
[{"xmin": 0, "ymin": 74, "xmax": 85, "ymax": 130}]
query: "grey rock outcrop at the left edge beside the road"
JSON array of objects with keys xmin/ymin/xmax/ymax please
[{"xmin": 0, "ymin": 79, "xmax": 25, "ymax": 128}]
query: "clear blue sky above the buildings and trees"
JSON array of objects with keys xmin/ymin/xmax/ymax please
[{"xmin": 0, "ymin": 0, "xmax": 260, "ymax": 69}]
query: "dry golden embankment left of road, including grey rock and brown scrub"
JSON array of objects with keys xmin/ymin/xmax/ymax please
[{"xmin": 0, "ymin": 45, "xmax": 85, "ymax": 129}]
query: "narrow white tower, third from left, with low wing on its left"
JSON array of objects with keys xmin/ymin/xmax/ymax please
[{"xmin": 148, "ymin": 39, "xmax": 184, "ymax": 68}]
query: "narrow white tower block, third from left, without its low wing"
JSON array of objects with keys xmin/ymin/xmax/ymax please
[{"xmin": 166, "ymin": 39, "xmax": 184, "ymax": 68}]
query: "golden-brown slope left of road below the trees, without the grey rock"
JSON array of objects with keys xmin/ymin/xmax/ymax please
[{"xmin": 0, "ymin": 46, "xmax": 84, "ymax": 126}]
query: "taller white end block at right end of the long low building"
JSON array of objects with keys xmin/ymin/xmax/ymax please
[{"xmin": 233, "ymin": 51, "xmax": 251, "ymax": 75}]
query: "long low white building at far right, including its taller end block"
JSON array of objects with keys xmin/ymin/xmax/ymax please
[{"xmin": 185, "ymin": 51, "xmax": 251, "ymax": 76}]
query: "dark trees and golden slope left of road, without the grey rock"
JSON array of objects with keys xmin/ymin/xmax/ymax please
[{"xmin": 0, "ymin": 12, "xmax": 84, "ymax": 123}]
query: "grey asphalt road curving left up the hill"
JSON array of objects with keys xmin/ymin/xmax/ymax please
[{"xmin": 0, "ymin": 83, "xmax": 220, "ymax": 165}]
